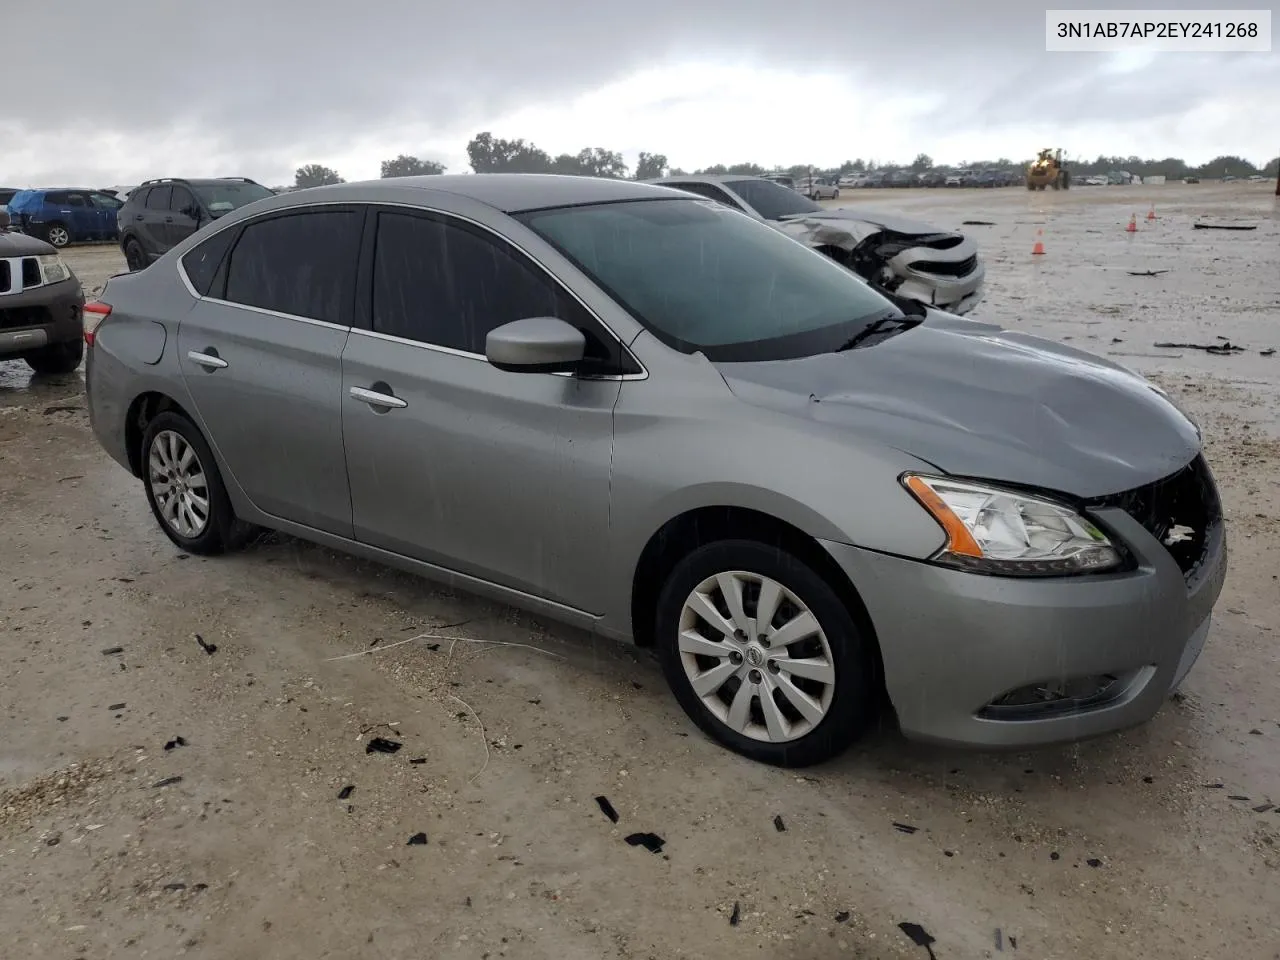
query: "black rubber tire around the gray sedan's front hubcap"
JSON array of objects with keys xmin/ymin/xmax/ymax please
[{"xmin": 655, "ymin": 540, "xmax": 882, "ymax": 767}]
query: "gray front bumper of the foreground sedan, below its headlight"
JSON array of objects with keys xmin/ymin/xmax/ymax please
[{"xmin": 823, "ymin": 508, "xmax": 1226, "ymax": 748}]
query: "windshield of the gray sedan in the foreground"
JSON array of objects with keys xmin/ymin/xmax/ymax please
[{"xmin": 517, "ymin": 197, "xmax": 899, "ymax": 362}]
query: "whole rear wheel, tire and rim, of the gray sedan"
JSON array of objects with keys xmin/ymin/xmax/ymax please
[{"xmin": 142, "ymin": 411, "xmax": 252, "ymax": 556}]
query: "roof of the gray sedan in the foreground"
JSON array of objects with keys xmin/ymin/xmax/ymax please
[{"xmin": 282, "ymin": 173, "xmax": 668, "ymax": 214}]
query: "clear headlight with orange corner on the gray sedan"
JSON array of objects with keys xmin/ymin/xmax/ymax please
[{"xmin": 902, "ymin": 474, "xmax": 1123, "ymax": 576}]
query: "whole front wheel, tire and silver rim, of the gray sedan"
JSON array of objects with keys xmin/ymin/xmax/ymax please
[{"xmin": 655, "ymin": 540, "xmax": 879, "ymax": 767}]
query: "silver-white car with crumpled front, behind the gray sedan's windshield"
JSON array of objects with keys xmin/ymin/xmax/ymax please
[{"xmin": 649, "ymin": 175, "xmax": 986, "ymax": 315}]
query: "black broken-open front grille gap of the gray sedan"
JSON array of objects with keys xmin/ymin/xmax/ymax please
[{"xmin": 1096, "ymin": 454, "xmax": 1222, "ymax": 580}]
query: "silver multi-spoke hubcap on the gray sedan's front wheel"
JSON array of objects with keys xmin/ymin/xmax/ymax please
[{"xmin": 680, "ymin": 570, "xmax": 836, "ymax": 742}]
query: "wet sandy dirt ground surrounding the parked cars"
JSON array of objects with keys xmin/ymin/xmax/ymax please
[{"xmin": 0, "ymin": 184, "xmax": 1280, "ymax": 960}]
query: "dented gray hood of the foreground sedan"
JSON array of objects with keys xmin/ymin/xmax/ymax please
[{"xmin": 717, "ymin": 311, "xmax": 1201, "ymax": 499}]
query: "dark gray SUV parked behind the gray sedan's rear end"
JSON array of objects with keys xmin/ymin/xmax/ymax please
[{"xmin": 118, "ymin": 177, "xmax": 275, "ymax": 270}]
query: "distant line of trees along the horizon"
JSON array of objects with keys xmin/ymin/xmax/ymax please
[{"xmin": 294, "ymin": 131, "xmax": 1280, "ymax": 187}]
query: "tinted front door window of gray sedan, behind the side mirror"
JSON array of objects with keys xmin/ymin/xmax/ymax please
[{"xmin": 374, "ymin": 212, "xmax": 604, "ymax": 360}]
